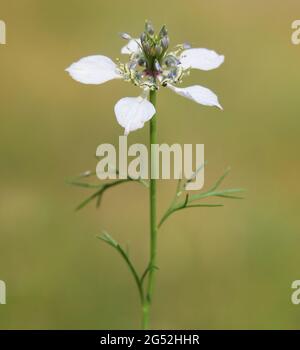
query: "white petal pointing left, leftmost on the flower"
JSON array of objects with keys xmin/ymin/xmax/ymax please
[{"xmin": 66, "ymin": 55, "xmax": 121, "ymax": 84}]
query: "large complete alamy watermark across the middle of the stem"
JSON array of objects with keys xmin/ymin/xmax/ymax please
[{"xmin": 96, "ymin": 136, "xmax": 204, "ymax": 191}]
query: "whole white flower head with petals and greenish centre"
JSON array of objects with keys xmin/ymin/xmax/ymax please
[{"xmin": 66, "ymin": 24, "xmax": 224, "ymax": 135}]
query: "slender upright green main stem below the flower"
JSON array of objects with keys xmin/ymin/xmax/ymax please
[{"xmin": 142, "ymin": 90, "xmax": 157, "ymax": 329}]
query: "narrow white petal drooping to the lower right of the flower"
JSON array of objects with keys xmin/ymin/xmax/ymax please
[{"xmin": 168, "ymin": 85, "xmax": 223, "ymax": 109}]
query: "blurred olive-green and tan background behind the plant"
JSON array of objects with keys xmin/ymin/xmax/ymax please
[{"xmin": 0, "ymin": 0, "xmax": 300, "ymax": 329}]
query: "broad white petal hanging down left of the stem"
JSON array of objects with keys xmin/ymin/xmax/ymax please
[{"xmin": 115, "ymin": 97, "xmax": 156, "ymax": 135}]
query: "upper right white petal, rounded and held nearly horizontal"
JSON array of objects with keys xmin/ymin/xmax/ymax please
[{"xmin": 180, "ymin": 49, "xmax": 224, "ymax": 70}]
